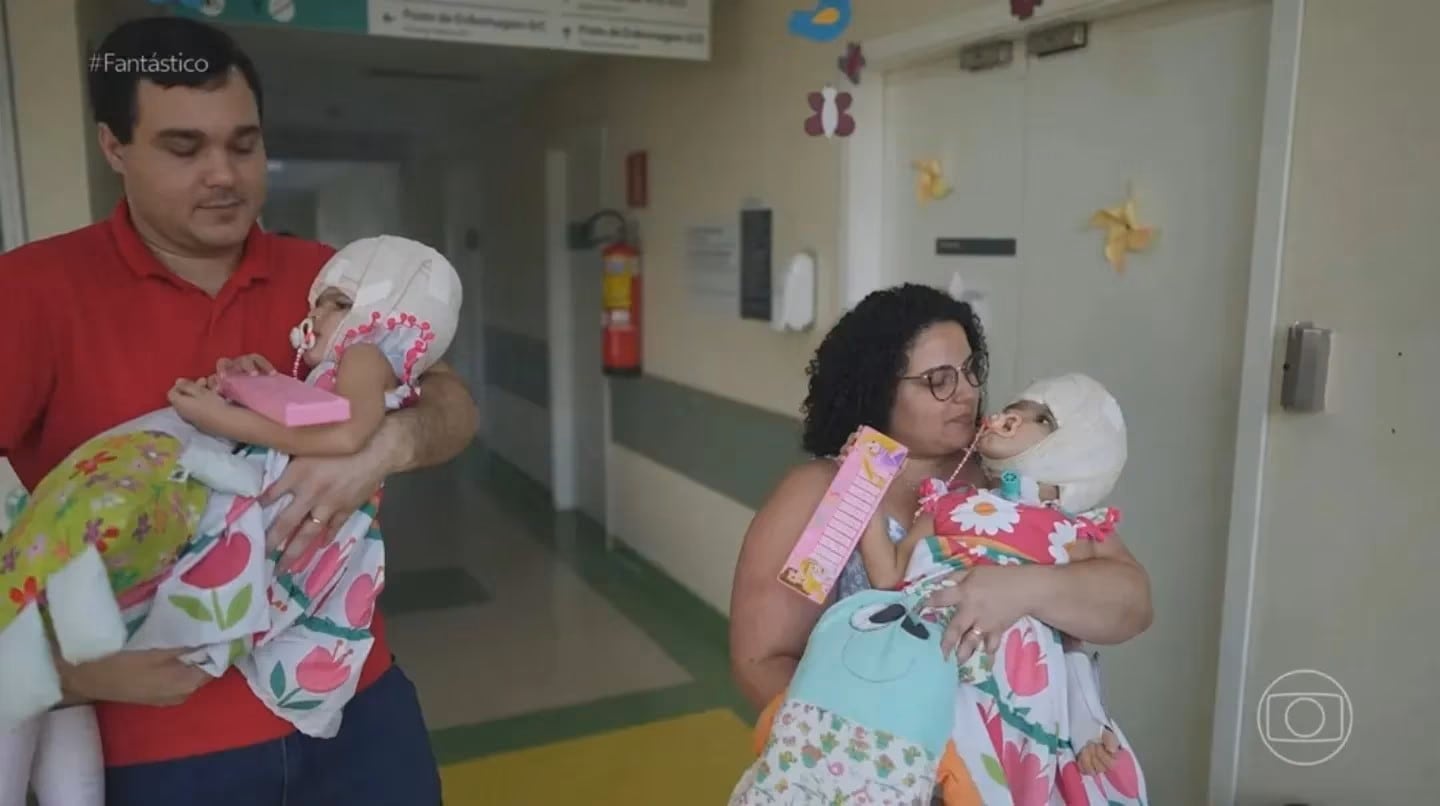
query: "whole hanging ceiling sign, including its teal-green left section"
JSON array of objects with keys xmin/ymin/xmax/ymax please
[{"xmin": 173, "ymin": 0, "xmax": 710, "ymax": 60}]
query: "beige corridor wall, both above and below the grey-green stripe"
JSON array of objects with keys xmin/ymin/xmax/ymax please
[{"xmin": 485, "ymin": 0, "xmax": 979, "ymax": 612}]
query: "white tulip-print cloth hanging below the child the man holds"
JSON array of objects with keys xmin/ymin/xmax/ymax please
[{"xmin": 124, "ymin": 434, "xmax": 384, "ymax": 738}]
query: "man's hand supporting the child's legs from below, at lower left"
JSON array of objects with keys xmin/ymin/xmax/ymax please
[{"xmin": 55, "ymin": 649, "xmax": 213, "ymax": 705}]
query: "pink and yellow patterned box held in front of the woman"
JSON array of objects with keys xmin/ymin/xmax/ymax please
[{"xmin": 779, "ymin": 427, "xmax": 909, "ymax": 605}]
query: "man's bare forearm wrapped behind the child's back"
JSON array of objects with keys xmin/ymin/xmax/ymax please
[{"xmin": 374, "ymin": 361, "xmax": 480, "ymax": 474}]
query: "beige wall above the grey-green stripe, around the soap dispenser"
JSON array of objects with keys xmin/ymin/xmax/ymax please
[{"xmin": 528, "ymin": 0, "xmax": 976, "ymax": 415}]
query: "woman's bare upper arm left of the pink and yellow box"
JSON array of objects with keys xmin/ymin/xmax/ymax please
[{"xmin": 730, "ymin": 461, "xmax": 835, "ymax": 710}]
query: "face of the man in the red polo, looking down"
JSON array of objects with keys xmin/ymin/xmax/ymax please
[{"xmin": 101, "ymin": 69, "xmax": 265, "ymax": 253}]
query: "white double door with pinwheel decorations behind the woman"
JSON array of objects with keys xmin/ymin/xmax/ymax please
[{"xmin": 886, "ymin": 0, "xmax": 1270, "ymax": 803}]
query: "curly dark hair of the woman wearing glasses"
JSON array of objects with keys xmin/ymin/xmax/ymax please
[{"xmin": 801, "ymin": 284, "xmax": 986, "ymax": 456}]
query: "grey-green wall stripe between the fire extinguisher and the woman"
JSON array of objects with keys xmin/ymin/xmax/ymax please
[{"xmin": 611, "ymin": 376, "xmax": 806, "ymax": 510}]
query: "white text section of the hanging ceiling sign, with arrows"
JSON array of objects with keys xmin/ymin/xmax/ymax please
[{"xmin": 369, "ymin": 0, "xmax": 710, "ymax": 60}]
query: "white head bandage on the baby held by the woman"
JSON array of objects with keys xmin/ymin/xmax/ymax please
[{"xmin": 986, "ymin": 373, "xmax": 1128, "ymax": 512}]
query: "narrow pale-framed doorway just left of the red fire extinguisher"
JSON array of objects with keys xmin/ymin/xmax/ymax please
[{"xmin": 546, "ymin": 128, "xmax": 609, "ymax": 524}]
